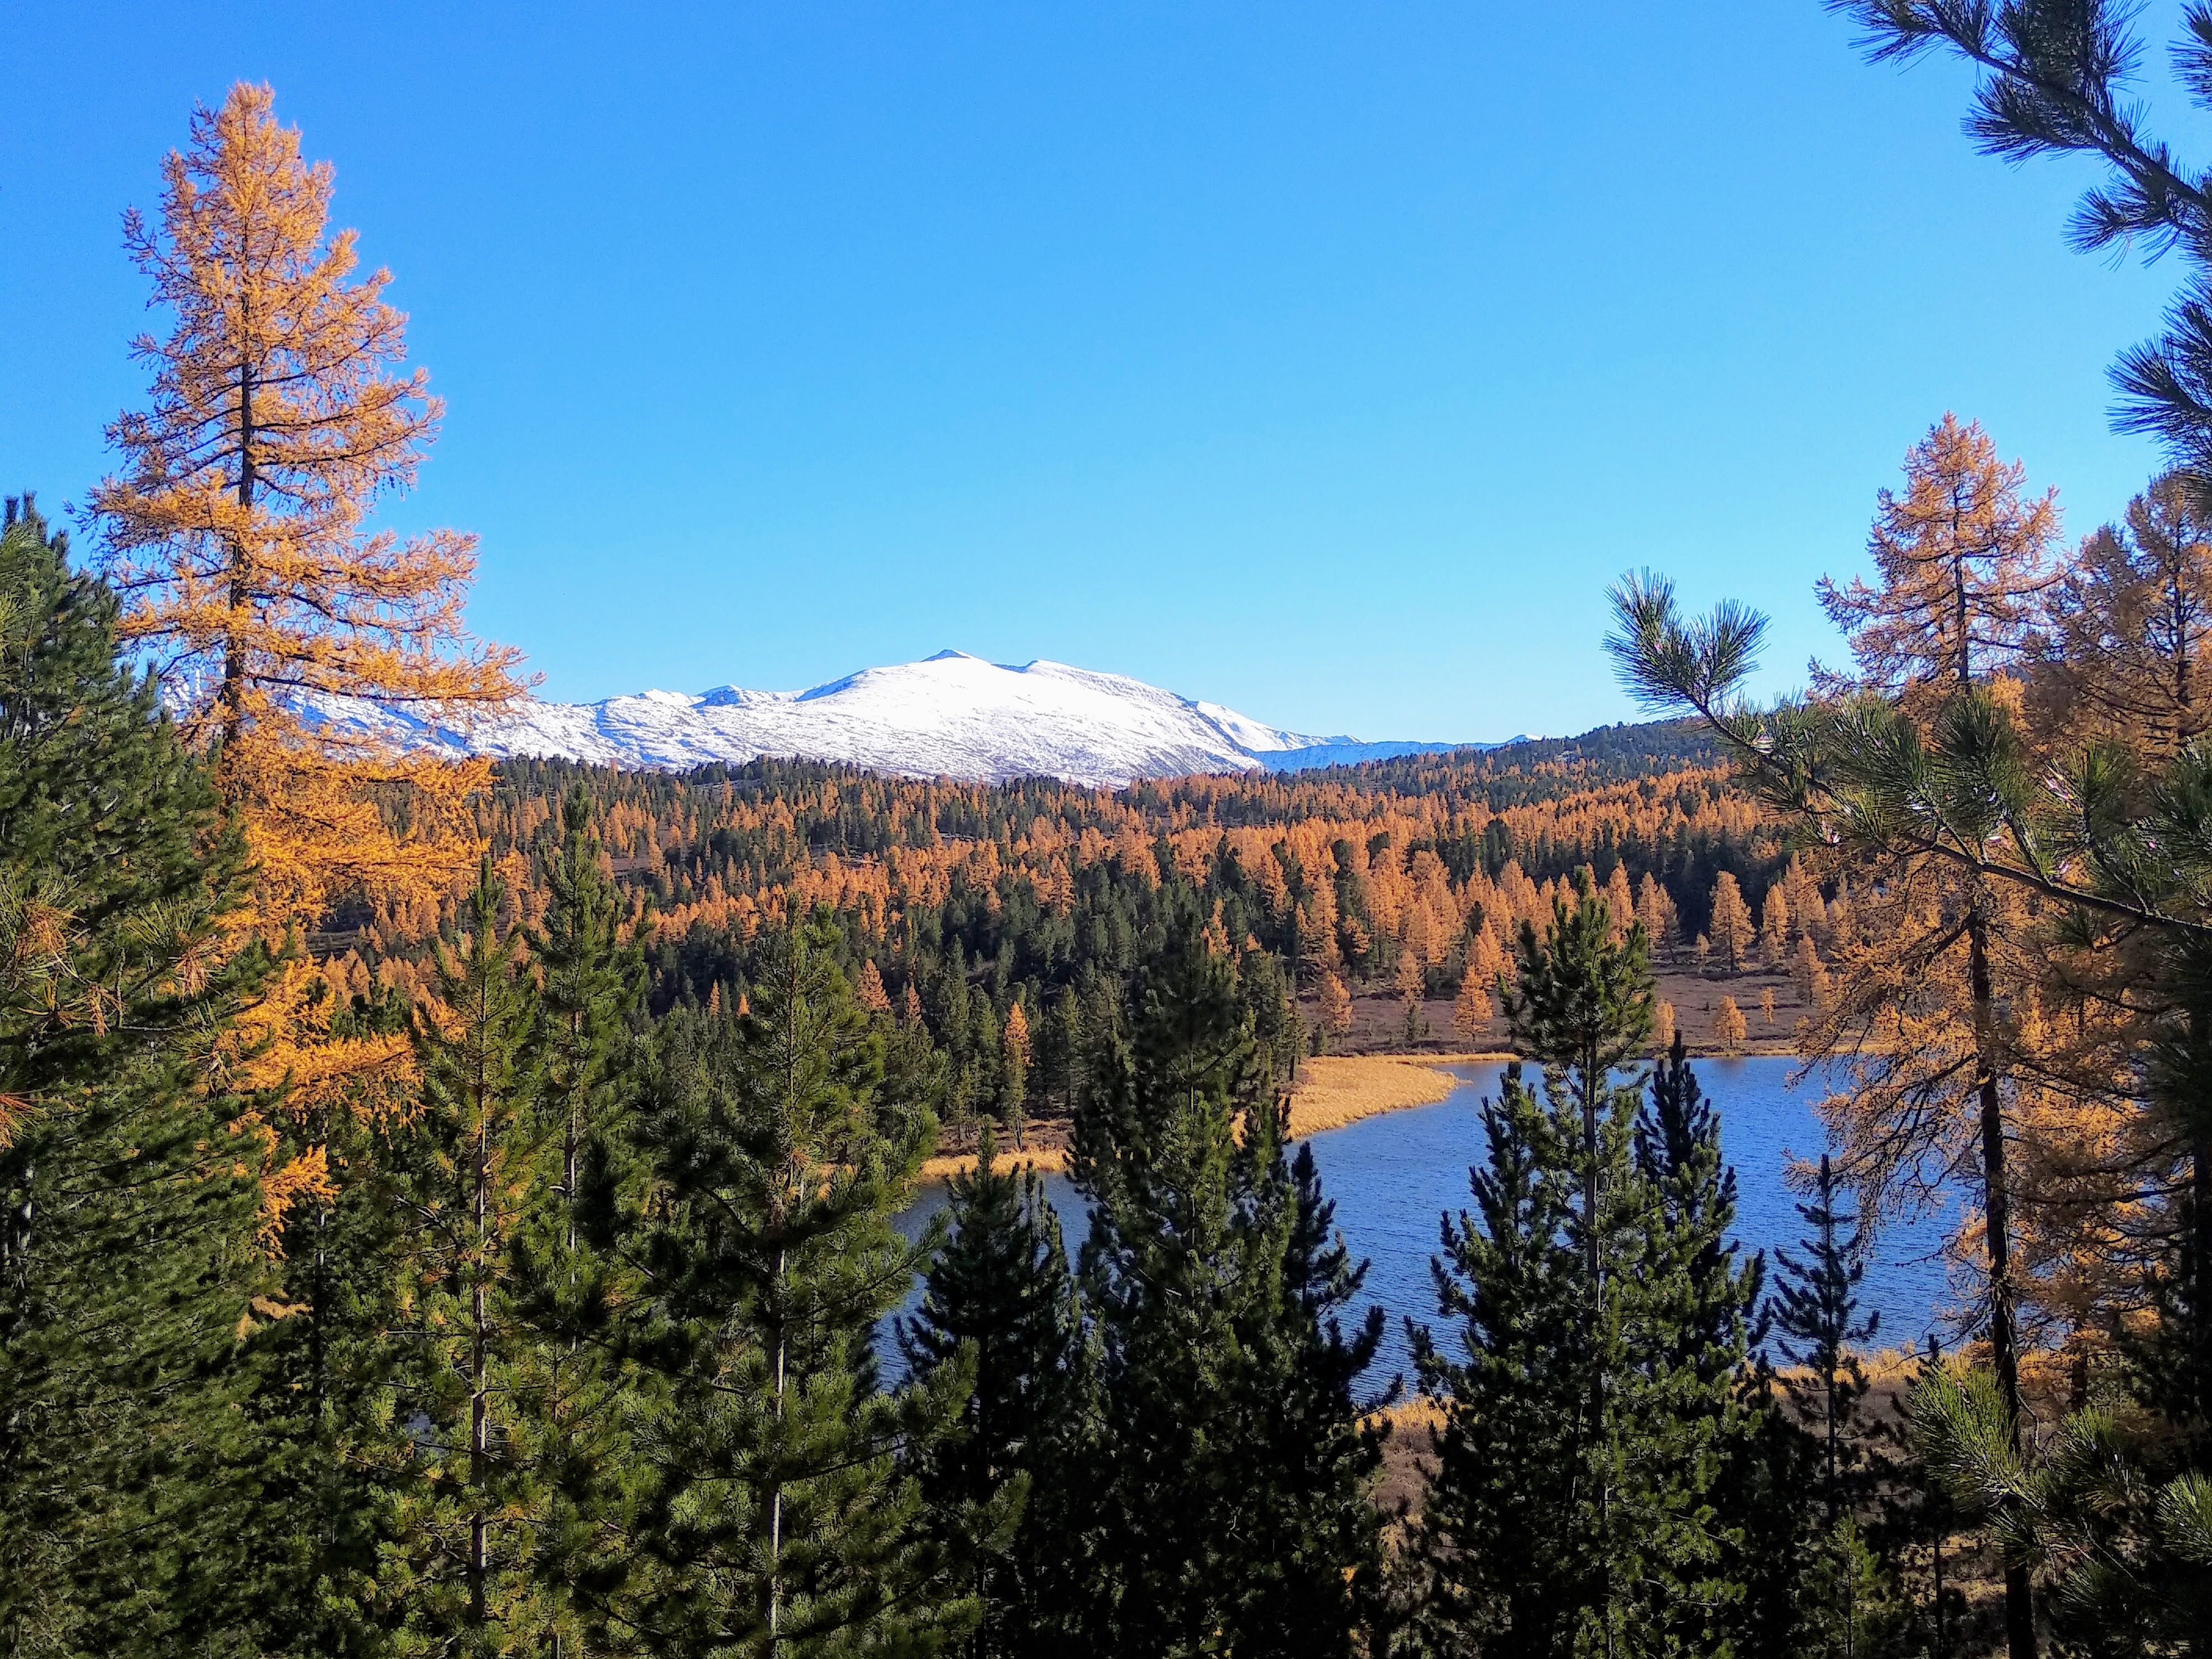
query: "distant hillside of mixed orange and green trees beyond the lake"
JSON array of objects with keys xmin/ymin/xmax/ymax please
[{"xmin": 319, "ymin": 726, "xmax": 1827, "ymax": 1106}]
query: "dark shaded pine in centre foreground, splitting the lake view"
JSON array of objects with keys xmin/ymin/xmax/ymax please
[{"xmin": 1066, "ymin": 925, "xmax": 1376, "ymax": 1655}]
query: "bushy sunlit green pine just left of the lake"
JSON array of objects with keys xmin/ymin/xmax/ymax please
[{"xmin": 633, "ymin": 920, "xmax": 975, "ymax": 1659}]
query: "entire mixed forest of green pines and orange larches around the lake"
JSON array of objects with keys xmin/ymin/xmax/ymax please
[{"xmin": 13, "ymin": 0, "xmax": 2212, "ymax": 1659}]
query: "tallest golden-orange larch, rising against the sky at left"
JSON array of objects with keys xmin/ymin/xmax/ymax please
[{"xmin": 88, "ymin": 84, "xmax": 518, "ymax": 1237}]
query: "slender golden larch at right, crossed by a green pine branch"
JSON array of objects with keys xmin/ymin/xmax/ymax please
[{"xmin": 1798, "ymin": 414, "xmax": 2059, "ymax": 1655}]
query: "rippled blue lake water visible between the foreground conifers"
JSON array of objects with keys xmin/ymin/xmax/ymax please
[{"xmin": 894, "ymin": 1057, "xmax": 1955, "ymax": 1389}]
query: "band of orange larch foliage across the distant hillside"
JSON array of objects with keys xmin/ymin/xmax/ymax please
[{"xmin": 489, "ymin": 768, "xmax": 1765, "ymax": 973}]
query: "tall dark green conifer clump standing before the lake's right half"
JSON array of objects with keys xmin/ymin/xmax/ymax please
[{"xmin": 1413, "ymin": 878, "xmax": 1745, "ymax": 1655}]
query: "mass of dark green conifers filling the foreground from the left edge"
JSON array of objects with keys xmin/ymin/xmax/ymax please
[{"xmin": 0, "ymin": 473, "xmax": 1966, "ymax": 1655}]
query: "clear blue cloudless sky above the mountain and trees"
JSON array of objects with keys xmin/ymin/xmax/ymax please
[{"xmin": 0, "ymin": 0, "xmax": 2197, "ymax": 739}]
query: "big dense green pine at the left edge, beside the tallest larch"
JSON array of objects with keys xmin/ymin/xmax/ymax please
[{"xmin": 0, "ymin": 498, "xmax": 274, "ymax": 1655}]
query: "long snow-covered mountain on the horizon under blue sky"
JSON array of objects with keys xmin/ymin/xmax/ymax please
[{"xmin": 290, "ymin": 650, "xmax": 1475, "ymax": 785}]
